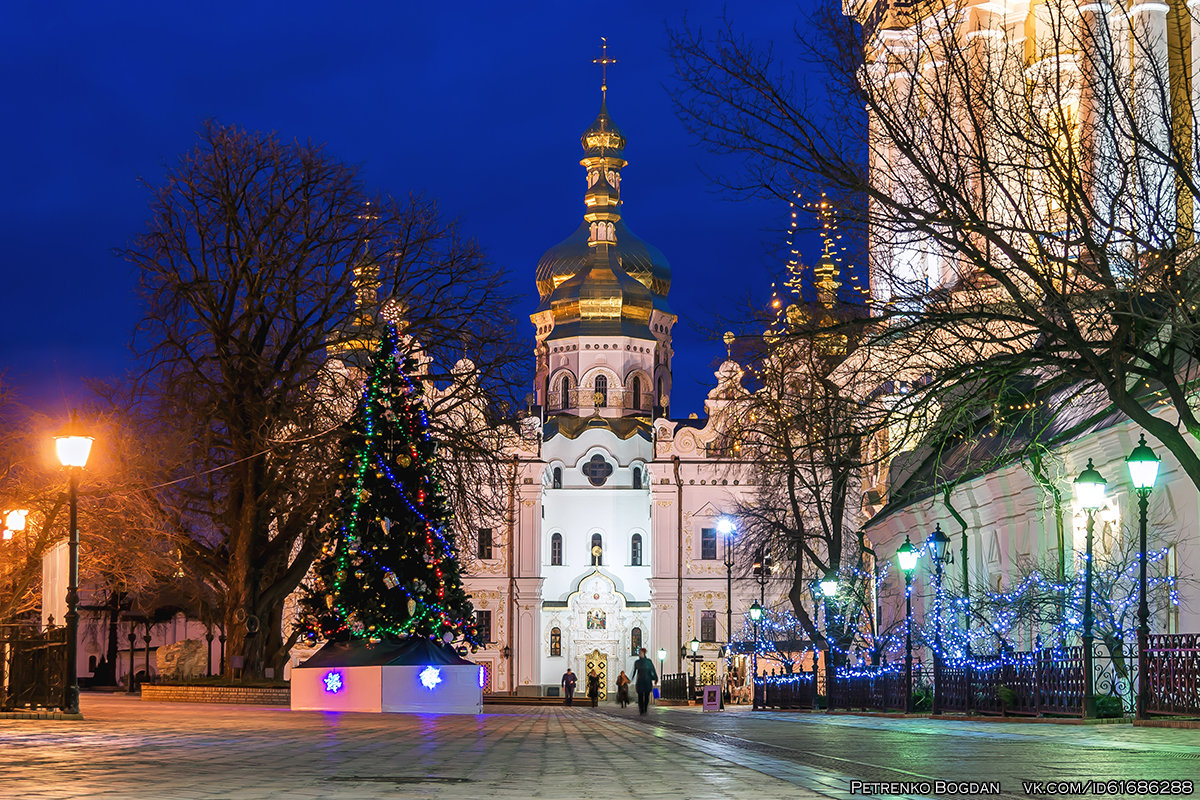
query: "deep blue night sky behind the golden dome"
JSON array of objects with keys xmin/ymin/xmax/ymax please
[{"xmin": 0, "ymin": 0, "xmax": 816, "ymax": 414}]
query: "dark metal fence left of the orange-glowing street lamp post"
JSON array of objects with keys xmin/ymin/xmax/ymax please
[{"xmin": 0, "ymin": 625, "xmax": 67, "ymax": 711}]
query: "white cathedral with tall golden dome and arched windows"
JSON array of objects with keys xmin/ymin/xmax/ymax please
[{"xmin": 453, "ymin": 77, "xmax": 760, "ymax": 694}]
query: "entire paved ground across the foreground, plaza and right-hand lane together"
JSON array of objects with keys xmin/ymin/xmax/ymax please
[{"xmin": 0, "ymin": 694, "xmax": 1200, "ymax": 800}]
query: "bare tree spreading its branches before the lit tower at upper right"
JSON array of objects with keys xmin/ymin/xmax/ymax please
[{"xmin": 672, "ymin": 0, "xmax": 1200, "ymax": 487}]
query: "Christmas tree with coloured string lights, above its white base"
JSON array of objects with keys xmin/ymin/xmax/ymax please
[{"xmin": 301, "ymin": 325, "xmax": 478, "ymax": 644}]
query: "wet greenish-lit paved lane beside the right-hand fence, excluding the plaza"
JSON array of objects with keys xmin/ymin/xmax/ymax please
[{"xmin": 606, "ymin": 706, "xmax": 1200, "ymax": 798}]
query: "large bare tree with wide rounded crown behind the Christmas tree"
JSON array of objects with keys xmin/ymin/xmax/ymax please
[{"xmin": 124, "ymin": 124, "xmax": 521, "ymax": 673}]
